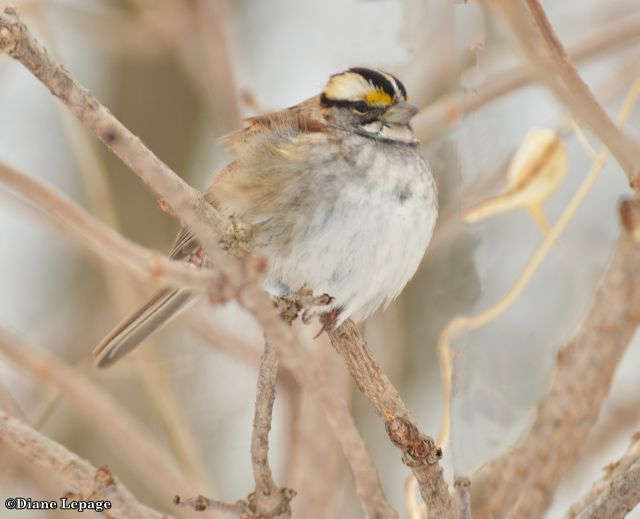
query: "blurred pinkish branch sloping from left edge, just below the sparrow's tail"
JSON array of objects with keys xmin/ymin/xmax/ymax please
[{"xmin": 0, "ymin": 329, "xmax": 198, "ymax": 510}]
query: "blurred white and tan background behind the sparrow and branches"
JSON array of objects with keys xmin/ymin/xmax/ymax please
[{"xmin": 0, "ymin": 0, "xmax": 640, "ymax": 517}]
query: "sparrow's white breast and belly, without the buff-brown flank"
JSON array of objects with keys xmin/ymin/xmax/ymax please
[{"xmin": 265, "ymin": 139, "xmax": 437, "ymax": 324}]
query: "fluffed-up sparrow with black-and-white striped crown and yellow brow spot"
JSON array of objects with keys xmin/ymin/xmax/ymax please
[{"xmin": 94, "ymin": 67, "xmax": 438, "ymax": 367}]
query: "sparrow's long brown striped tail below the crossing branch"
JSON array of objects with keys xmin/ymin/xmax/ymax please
[{"xmin": 93, "ymin": 288, "xmax": 197, "ymax": 368}]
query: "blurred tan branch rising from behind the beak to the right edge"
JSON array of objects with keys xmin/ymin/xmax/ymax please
[{"xmin": 413, "ymin": 12, "xmax": 640, "ymax": 141}]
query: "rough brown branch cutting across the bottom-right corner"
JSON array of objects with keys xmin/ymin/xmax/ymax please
[{"xmin": 565, "ymin": 433, "xmax": 640, "ymax": 519}]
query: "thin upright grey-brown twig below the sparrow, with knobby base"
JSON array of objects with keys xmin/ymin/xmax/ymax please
[{"xmin": 248, "ymin": 340, "xmax": 296, "ymax": 517}]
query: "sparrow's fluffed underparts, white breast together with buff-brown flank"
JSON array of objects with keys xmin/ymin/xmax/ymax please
[{"xmin": 211, "ymin": 128, "xmax": 437, "ymax": 324}]
